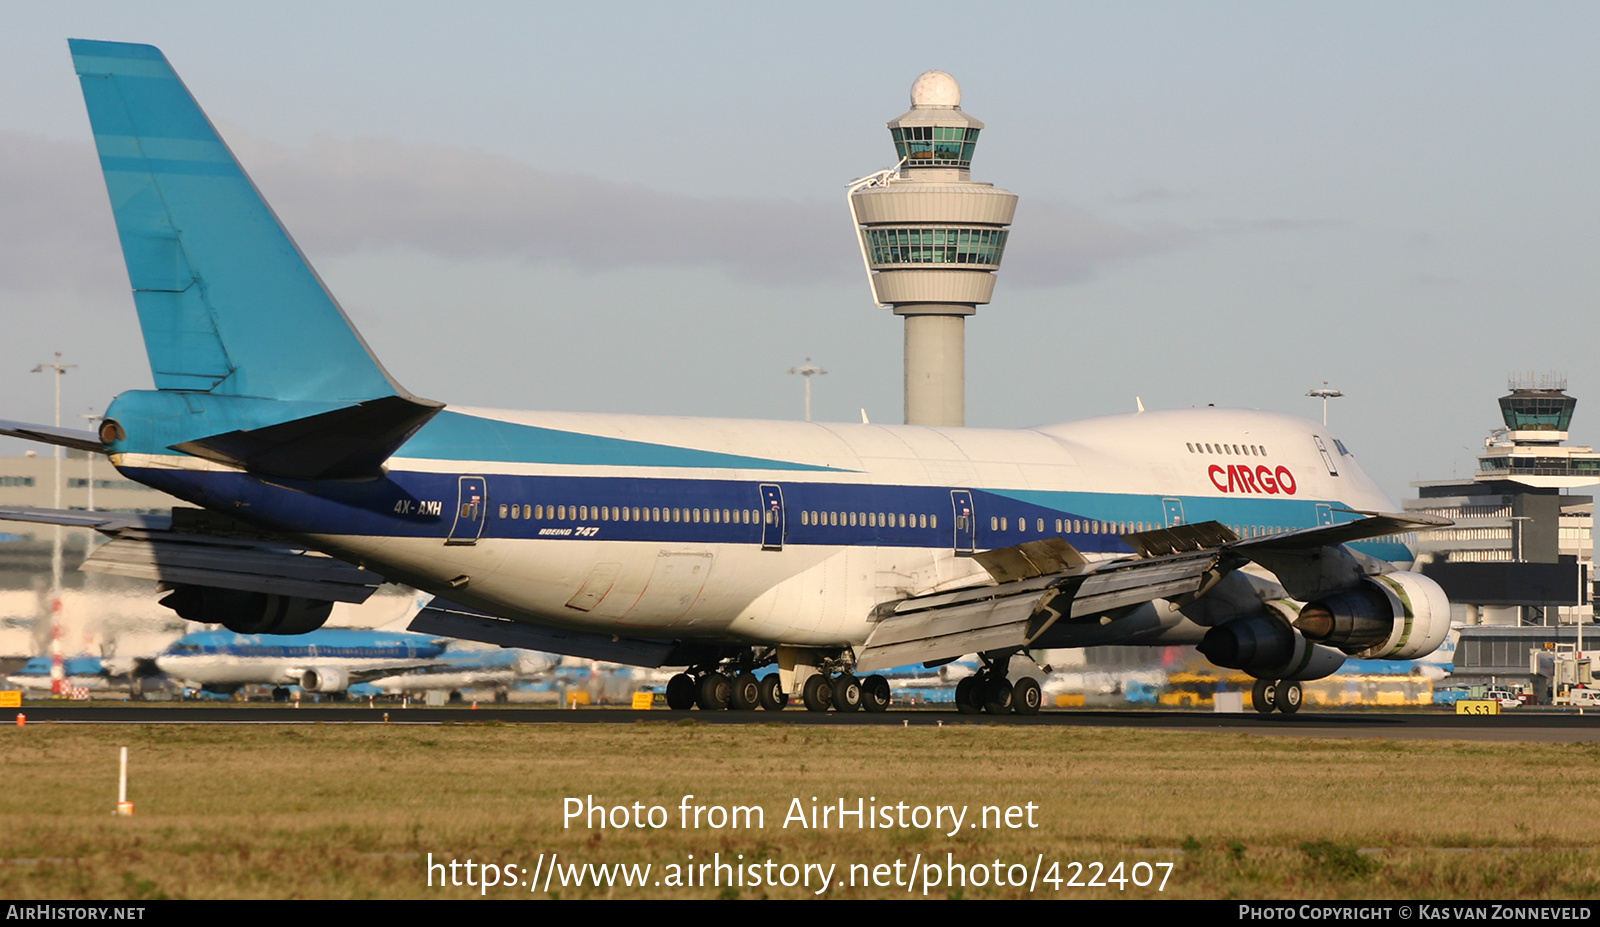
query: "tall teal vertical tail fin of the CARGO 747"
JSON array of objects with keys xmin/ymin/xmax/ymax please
[{"xmin": 70, "ymin": 38, "xmax": 410, "ymax": 402}]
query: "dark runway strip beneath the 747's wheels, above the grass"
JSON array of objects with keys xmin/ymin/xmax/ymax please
[{"xmin": 12, "ymin": 701, "xmax": 1600, "ymax": 743}]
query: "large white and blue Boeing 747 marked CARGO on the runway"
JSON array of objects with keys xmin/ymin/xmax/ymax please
[{"xmin": 0, "ymin": 40, "xmax": 1450, "ymax": 712}]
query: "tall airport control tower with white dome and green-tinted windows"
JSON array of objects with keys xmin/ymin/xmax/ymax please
[{"xmin": 850, "ymin": 70, "xmax": 1016, "ymax": 426}]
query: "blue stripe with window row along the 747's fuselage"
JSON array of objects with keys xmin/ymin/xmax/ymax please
[{"xmin": 123, "ymin": 468, "xmax": 1410, "ymax": 560}]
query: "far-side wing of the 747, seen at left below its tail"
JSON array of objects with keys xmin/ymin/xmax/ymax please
[{"xmin": 0, "ymin": 508, "xmax": 384, "ymax": 604}]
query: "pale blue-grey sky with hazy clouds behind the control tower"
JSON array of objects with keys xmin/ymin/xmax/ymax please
[{"xmin": 0, "ymin": 0, "xmax": 1600, "ymax": 500}]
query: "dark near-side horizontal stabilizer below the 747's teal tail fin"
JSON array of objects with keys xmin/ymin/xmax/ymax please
[{"xmin": 173, "ymin": 395, "xmax": 445, "ymax": 480}]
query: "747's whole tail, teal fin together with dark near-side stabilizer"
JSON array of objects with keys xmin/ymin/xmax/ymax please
[{"xmin": 69, "ymin": 38, "xmax": 442, "ymax": 479}]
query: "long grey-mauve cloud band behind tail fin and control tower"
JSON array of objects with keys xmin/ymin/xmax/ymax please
[{"xmin": 0, "ymin": 131, "xmax": 1197, "ymax": 290}]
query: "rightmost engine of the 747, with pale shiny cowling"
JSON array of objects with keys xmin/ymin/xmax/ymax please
[{"xmin": 1294, "ymin": 573, "xmax": 1450, "ymax": 660}]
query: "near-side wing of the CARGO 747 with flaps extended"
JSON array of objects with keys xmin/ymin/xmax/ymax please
[{"xmin": 856, "ymin": 512, "xmax": 1450, "ymax": 671}]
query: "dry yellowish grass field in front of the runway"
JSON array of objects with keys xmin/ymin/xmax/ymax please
[{"xmin": 0, "ymin": 720, "xmax": 1600, "ymax": 900}]
